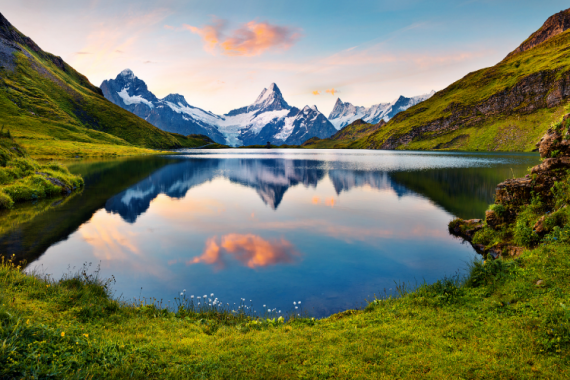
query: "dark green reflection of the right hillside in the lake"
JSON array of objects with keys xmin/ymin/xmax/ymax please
[{"xmin": 390, "ymin": 166, "xmax": 527, "ymax": 218}]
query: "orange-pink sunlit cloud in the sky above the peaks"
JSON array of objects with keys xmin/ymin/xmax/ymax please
[{"xmin": 183, "ymin": 18, "xmax": 301, "ymax": 57}]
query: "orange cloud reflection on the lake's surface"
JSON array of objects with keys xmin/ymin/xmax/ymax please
[{"xmin": 186, "ymin": 234, "xmax": 301, "ymax": 270}]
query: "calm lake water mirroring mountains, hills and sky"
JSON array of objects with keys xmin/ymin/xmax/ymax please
[{"xmin": 0, "ymin": 150, "xmax": 538, "ymax": 316}]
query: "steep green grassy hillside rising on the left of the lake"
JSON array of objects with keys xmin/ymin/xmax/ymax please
[{"xmin": 0, "ymin": 14, "xmax": 211, "ymax": 157}]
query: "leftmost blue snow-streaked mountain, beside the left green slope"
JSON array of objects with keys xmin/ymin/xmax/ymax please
[{"xmin": 101, "ymin": 69, "xmax": 226, "ymax": 144}]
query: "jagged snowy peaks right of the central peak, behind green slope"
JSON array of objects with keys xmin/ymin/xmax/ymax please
[{"xmin": 329, "ymin": 91, "xmax": 435, "ymax": 129}]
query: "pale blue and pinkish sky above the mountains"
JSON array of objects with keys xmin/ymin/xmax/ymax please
[{"xmin": 0, "ymin": 0, "xmax": 568, "ymax": 116}]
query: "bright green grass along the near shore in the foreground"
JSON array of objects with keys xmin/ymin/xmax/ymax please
[{"xmin": 0, "ymin": 169, "xmax": 570, "ymax": 379}]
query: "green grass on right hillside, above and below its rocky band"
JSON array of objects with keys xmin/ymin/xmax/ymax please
[{"xmin": 352, "ymin": 31, "xmax": 570, "ymax": 151}]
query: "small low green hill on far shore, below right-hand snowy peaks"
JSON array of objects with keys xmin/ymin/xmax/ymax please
[{"xmin": 302, "ymin": 119, "xmax": 386, "ymax": 149}]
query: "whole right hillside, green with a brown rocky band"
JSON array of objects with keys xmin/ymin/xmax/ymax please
[{"xmin": 354, "ymin": 9, "xmax": 570, "ymax": 151}]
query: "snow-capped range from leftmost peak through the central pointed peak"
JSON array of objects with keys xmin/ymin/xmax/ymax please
[{"xmin": 101, "ymin": 69, "xmax": 336, "ymax": 146}]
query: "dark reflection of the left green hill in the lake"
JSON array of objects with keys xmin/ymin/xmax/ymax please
[{"xmin": 0, "ymin": 157, "xmax": 173, "ymax": 262}]
